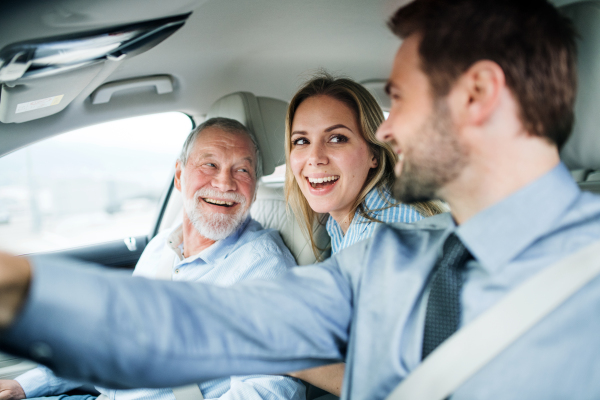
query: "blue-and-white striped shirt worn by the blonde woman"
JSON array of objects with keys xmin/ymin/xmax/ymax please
[{"xmin": 325, "ymin": 188, "xmax": 423, "ymax": 254}]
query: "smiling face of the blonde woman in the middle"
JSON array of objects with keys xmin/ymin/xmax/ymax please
[{"xmin": 290, "ymin": 96, "xmax": 377, "ymax": 223}]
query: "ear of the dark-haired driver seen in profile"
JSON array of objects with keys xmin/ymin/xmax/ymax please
[{"xmin": 451, "ymin": 60, "xmax": 506, "ymax": 125}]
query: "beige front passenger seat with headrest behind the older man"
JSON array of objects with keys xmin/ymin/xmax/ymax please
[{"xmin": 207, "ymin": 92, "xmax": 329, "ymax": 265}]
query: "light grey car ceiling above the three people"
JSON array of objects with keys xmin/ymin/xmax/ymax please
[{"xmin": 0, "ymin": 0, "xmax": 592, "ymax": 158}]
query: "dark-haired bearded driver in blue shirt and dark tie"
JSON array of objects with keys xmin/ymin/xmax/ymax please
[{"xmin": 0, "ymin": 0, "xmax": 600, "ymax": 400}]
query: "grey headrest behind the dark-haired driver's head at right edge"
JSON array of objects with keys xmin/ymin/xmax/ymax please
[{"xmin": 561, "ymin": 2, "xmax": 600, "ymax": 170}]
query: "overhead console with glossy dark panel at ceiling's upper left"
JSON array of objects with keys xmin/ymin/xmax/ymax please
[{"xmin": 0, "ymin": 13, "xmax": 190, "ymax": 123}]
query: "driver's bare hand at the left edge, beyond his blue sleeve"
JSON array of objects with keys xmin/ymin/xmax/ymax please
[{"xmin": 0, "ymin": 252, "xmax": 31, "ymax": 328}]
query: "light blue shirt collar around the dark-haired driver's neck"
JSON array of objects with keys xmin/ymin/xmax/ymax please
[{"xmin": 456, "ymin": 163, "xmax": 581, "ymax": 271}]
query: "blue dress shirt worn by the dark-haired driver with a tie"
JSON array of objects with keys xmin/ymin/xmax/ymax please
[{"xmin": 0, "ymin": 164, "xmax": 600, "ymax": 400}]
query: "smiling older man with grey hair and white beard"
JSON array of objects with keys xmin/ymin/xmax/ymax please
[{"xmin": 0, "ymin": 118, "xmax": 305, "ymax": 400}]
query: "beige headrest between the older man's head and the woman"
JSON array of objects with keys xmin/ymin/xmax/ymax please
[{"xmin": 207, "ymin": 92, "xmax": 288, "ymax": 175}]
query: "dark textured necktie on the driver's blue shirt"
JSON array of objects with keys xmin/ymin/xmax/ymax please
[{"xmin": 421, "ymin": 233, "xmax": 473, "ymax": 359}]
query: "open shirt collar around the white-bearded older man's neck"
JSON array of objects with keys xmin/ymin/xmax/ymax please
[{"xmin": 167, "ymin": 216, "xmax": 251, "ymax": 264}]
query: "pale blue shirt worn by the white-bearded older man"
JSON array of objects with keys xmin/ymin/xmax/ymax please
[{"xmin": 16, "ymin": 218, "xmax": 305, "ymax": 400}]
